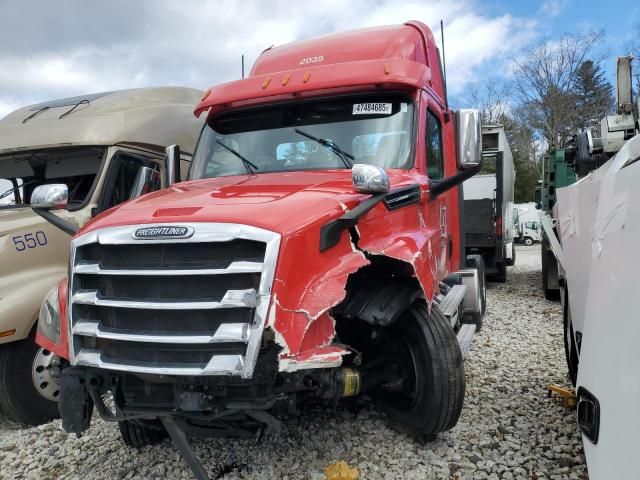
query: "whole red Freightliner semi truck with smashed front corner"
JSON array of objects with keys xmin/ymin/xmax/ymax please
[{"xmin": 36, "ymin": 21, "xmax": 485, "ymax": 477}]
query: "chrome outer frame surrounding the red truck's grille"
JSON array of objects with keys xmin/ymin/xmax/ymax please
[{"xmin": 67, "ymin": 223, "xmax": 281, "ymax": 379}]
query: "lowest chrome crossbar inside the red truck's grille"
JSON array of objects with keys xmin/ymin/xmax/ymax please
[{"xmin": 75, "ymin": 349, "xmax": 245, "ymax": 376}]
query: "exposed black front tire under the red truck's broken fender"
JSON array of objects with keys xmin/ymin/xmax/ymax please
[{"xmin": 382, "ymin": 301, "xmax": 465, "ymax": 440}]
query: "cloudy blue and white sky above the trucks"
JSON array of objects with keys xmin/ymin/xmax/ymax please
[{"xmin": 0, "ymin": 0, "xmax": 640, "ymax": 118}]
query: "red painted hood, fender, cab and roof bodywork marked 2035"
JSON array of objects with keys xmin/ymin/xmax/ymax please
[{"xmin": 58, "ymin": 22, "xmax": 460, "ymax": 374}]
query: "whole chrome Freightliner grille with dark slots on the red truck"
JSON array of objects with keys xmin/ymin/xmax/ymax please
[{"xmin": 68, "ymin": 223, "xmax": 280, "ymax": 378}]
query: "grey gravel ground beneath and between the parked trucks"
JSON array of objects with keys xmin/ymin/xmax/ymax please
[{"xmin": 0, "ymin": 246, "xmax": 588, "ymax": 480}]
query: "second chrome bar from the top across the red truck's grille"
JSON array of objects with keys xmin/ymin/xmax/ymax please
[{"xmin": 71, "ymin": 289, "xmax": 258, "ymax": 310}]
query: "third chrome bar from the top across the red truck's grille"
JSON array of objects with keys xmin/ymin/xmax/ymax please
[{"xmin": 73, "ymin": 320, "xmax": 249, "ymax": 344}]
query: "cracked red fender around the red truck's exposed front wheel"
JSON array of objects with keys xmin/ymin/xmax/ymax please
[{"xmin": 267, "ymin": 198, "xmax": 439, "ymax": 371}]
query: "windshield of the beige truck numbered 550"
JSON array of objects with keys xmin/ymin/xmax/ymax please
[{"xmin": 0, "ymin": 147, "xmax": 104, "ymax": 210}]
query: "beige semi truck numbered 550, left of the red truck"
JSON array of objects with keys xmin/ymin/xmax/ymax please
[{"xmin": 0, "ymin": 87, "xmax": 202, "ymax": 425}]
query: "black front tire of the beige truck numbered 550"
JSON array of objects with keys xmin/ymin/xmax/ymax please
[{"xmin": 0, "ymin": 331, "xmax": 60, "ymax": 425}]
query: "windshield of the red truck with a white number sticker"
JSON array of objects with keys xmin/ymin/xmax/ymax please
[{"xmin": 191, "ymin": 94, "xmax": 414, "ymax": 179}]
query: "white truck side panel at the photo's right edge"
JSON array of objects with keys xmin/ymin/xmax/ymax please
[{"xmin": 558, "ymin": 135, "xmax": 640, "ymax": 480}]
